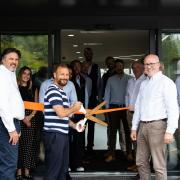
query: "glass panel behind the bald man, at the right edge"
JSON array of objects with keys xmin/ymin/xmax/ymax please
[{"xmin": 161, "ymin": 33, "xmax": 180, "ymax": 170}]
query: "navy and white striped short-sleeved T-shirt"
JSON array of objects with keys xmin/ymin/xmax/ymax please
[{"xmin": 43, "ymin": 84, "xmax": 69, "ymax": 134}]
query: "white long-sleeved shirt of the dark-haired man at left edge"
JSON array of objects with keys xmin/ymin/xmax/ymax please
[{"xmin": 0, "ymin": 65, "xmax": 25, "ymax": 132}]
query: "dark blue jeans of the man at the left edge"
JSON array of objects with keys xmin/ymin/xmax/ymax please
[{"xmin": 0, "ymin": 118, "xmax": 20, "ymax": 180}]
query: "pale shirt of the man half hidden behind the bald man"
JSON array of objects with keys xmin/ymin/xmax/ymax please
[{"xmin": 126, "ymin": 74, "xmax": 146, "ymax": 111}]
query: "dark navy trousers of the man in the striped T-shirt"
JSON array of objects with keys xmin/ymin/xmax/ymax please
[{"xmin": 43, "ymin": 132, "xmax": 69, "ymax": 180}]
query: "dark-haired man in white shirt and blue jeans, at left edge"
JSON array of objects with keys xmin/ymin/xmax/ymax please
[{"xmin": 0, "ymin": 48, "xmax": 24, "ymax": 180}]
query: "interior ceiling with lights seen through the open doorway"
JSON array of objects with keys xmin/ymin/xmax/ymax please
[{"xmin": 61, "ymin": 30, "xmax": 149, "ymax": 67}]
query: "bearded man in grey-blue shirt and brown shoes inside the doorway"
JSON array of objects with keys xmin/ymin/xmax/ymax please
[{"xmin": 104, "ymin": 59, "xmax": 131, "ymax": 162}]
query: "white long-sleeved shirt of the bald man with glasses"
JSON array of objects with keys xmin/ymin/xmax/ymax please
[{"xmin": 132, "ymin": 72, "xmax": 179, "ymax": 134}]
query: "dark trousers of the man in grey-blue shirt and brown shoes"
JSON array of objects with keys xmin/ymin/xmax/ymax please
[{"xmin": 109, "ymin": 105, "xmax": 132, "ymax": 153}]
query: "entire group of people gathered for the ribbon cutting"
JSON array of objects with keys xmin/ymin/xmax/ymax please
[{"xmin": 0, "ymin": 48, "xmax": 179, "ymax": 180}]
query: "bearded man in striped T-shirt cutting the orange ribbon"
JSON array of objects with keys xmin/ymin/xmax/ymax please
[{"xmin": 43, "ymin": 64, "xmax": 84, "ymax": 180}]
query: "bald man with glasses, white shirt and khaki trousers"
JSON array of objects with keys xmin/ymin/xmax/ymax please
[{"xmin": 131, "ymin": 54, "xmax": 179, "ymax": 180}]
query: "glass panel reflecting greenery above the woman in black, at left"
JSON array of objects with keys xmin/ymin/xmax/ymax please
[{"xmin": 1, "ymin": 35, "xmax": 48, "ymax": 72}]
